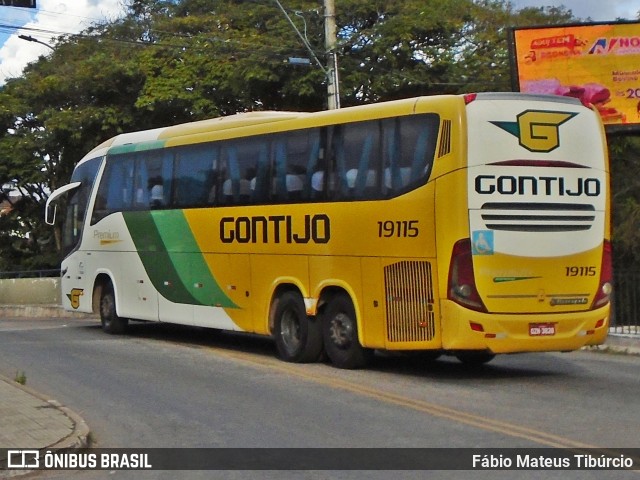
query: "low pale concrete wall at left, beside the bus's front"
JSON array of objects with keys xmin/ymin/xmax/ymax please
[{"xmin": 0, "ymin": 278, "xmax": 62, "ymax": 305}]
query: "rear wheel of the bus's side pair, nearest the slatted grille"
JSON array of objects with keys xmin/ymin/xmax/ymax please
[{"xmin": 322, "ymin": 293, "xmax": 373, "ymax": 369}]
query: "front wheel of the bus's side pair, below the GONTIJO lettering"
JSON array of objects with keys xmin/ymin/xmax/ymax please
[{"xmin": 273, "ymin": 291, "xmax": 322, "ymax": 363}]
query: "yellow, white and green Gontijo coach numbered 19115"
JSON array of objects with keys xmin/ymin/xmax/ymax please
[{"xmin": 45, "ymin": 93, "xmax": 612, "ymax": 368}]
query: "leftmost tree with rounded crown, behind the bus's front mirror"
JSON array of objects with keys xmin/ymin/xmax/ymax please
[{"xmin": 0, "ymin": 25, "xmax": 149, "ymax": 268}]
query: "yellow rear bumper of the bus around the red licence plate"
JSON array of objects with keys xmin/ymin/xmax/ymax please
[{"xmin": 441, "ymin": 300, "xmax": 610, "ymax": 353}]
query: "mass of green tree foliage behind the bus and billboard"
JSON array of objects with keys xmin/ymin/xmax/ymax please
[{"xmin": 0, "ymin": 0, "xmax": 640, "ymax": 269}]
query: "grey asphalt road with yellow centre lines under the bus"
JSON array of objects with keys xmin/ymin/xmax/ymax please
[{"xmin": 0, "ymin": 319, "xmax": 640, "ymax": 479}]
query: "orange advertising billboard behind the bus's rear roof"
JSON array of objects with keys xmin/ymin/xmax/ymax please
[{"xmin": 510, "ymin": 22, "xmax": 640, "ymax": 131}]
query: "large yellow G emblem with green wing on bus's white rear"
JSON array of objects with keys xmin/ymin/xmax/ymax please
[{"xmin": 491, "ymin": 110, "xmax": 577, "ymax": 153}]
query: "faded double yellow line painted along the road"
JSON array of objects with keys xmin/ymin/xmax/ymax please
[{"xmin": 198, "ymin": 346, "xmax": 606, "ymax": 452}]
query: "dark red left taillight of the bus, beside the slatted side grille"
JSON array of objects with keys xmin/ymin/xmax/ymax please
[{"xmin": 448, "ymin": 238, "xmax": 487, "ymax": 312}]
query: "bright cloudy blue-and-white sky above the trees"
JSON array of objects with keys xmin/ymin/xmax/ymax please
[{"xmin": 0, "ymin": 0, "xmax": 640, "ymax": 85}]
